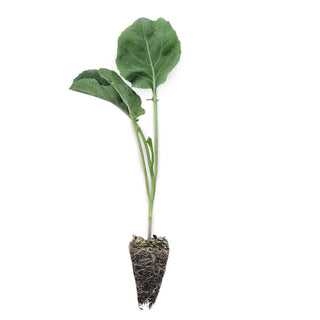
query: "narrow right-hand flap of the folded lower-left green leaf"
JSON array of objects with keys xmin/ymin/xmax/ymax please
[{"xmin": 99, "ymin": 68, "xmax": 144, "ymax": 119}]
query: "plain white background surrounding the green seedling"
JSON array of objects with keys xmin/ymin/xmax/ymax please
[{"xmin": 0, "ymin": 0, "xmax": 320, "ymax": 320}]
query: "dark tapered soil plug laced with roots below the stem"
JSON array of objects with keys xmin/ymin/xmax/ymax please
[{"xmin": 129, "ymin": 236, "xmax": 169, "ymax": 309}]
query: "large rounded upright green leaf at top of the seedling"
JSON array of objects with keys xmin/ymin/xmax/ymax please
[{"xmin": 116, "ymin": 18, "xmax": 181, "ymax": 90}]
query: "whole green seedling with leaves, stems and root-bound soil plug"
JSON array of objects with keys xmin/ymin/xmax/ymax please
[{"xmin": 70, "ymin": 18, "xmax": 181, "ymax": 308}]
